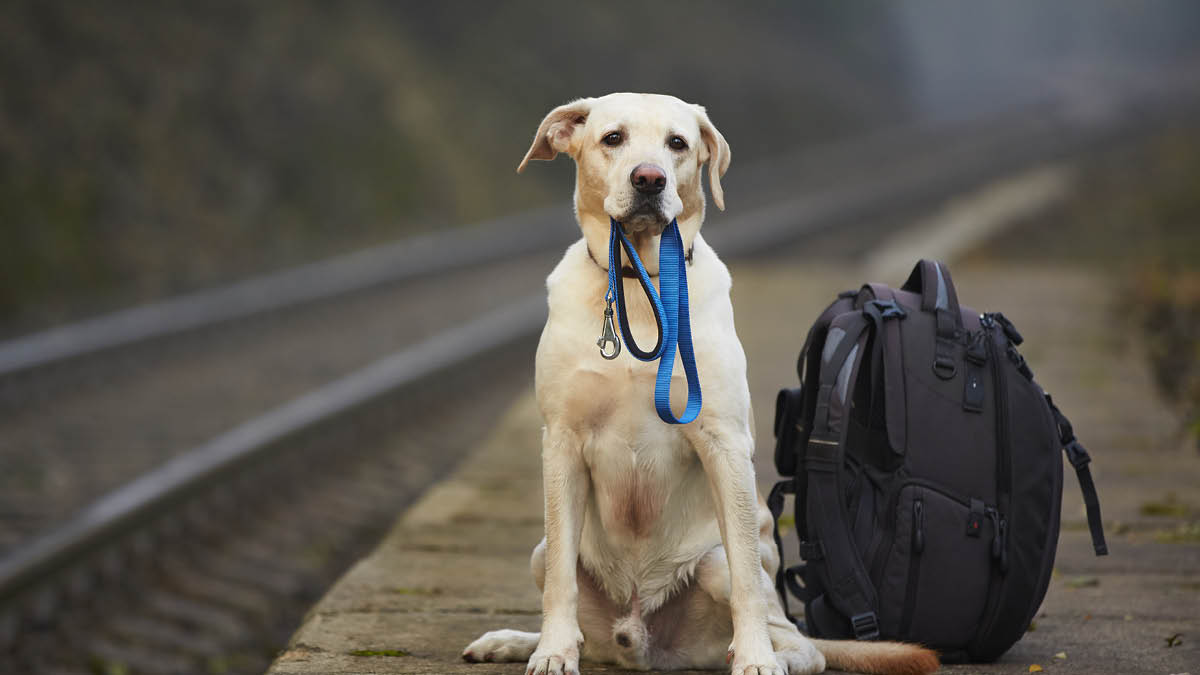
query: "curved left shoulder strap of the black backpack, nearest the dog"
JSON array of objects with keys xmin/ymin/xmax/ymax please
[{"xmin": 802, "ymin": 312, "xmax": 880, "ymax": 640}]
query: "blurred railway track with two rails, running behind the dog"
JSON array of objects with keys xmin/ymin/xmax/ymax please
[{"xmin": 0, "ymin": 88, "xmax": 1195, "ymax": 674}]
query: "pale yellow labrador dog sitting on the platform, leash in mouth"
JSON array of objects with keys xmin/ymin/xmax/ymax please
[{"xmin": 463, "ymin": 94, "xmax": 937, "ymax": 675}]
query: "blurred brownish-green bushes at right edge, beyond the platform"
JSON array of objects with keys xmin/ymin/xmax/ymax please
[{"xmin": 989, "ymin": 126, "xmax": 1200, "ymax": 444}]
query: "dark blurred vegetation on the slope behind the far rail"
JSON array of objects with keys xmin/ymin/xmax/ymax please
[{"xmin": 0, "ymin": 0, "xmax": 902, "ymax": 336}]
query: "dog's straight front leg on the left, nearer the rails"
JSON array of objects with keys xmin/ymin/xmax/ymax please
[{"xmin": 526, "ymin": 425, "xmax": 592, "ymax": 675}]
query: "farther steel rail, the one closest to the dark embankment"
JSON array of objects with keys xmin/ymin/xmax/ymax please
[{"xmin": 0, "ymin": 107, "xmax": 1070, "ymax": 377}]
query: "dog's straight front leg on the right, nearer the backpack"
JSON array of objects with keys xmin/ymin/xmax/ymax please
[{"xmin": 689, "ymin": 420, "xmax": 784, "ymax": 675}]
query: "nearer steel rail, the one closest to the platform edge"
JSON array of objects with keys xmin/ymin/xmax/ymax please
[{"xmin": 0, "ymin": 110, "xmax": 1084, "ymax": 624}]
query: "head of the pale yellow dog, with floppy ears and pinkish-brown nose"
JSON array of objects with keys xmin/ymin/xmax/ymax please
[{"xmin": 517, "ymin": 94, "xmax": 730, "ymax": 234}]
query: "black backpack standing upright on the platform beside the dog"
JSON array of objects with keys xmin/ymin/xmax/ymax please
[{"xmin": 768, "ymin": 261, "xmax": 1108, "ymax": 661}]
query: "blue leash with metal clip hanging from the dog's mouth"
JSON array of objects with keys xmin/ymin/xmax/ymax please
[{"xmin": 596, "ymin": 219, "xmax": 701, "ymax": 424}]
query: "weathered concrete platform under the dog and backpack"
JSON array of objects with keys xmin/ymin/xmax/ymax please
[{"xmin": 270, "ymin": 262, "xmax": 1200, "ymax": 675}]
